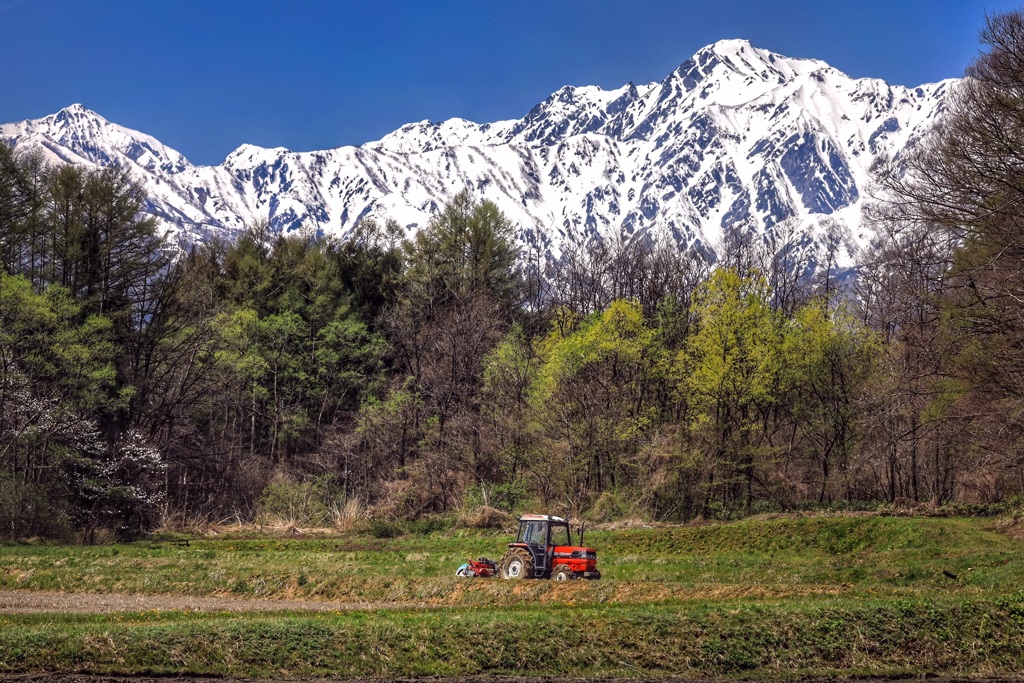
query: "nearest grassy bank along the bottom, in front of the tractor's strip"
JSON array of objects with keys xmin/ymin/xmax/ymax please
[{"xmin": 0, "ymin": 597, "xmax": 1024, "ymax": 679}]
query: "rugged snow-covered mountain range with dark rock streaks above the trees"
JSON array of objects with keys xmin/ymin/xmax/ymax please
[{"xmin": 0, "ymin": 40, "xmax": 953, "ymax": 259}]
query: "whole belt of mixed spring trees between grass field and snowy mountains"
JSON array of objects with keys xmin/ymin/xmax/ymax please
[{"xmin": 0, "ymin": 12, "xmax": 1024, "ymax": 541}]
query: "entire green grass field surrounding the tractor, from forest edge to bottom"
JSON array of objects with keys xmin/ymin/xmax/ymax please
[{"xmin": 0, "ymin": 516, "xmax": 1024, "ymax": 679}]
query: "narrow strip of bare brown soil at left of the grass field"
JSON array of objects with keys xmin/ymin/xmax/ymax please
[{"xmin": 0, "ymin": 591, "xmax": 416, "ymax": 614}]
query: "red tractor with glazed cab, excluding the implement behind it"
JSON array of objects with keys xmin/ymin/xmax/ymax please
[{"xmin": 499, "ymin": 515, "xmax": 601, "ymax": 581}]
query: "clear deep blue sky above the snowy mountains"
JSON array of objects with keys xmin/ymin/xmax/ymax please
[{"xmin": 0, "ymin": 0, "xmax": 1020, "ymax": 164}]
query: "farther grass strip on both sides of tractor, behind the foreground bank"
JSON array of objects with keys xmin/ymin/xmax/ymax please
[{"xmin": 0, "ymin": 517, "xmax": 1024, "ymax": 605}]
